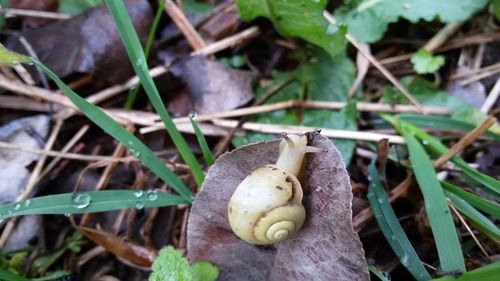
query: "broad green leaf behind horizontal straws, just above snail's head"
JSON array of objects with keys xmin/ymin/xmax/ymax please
[{"xmin": 233, "ymin": 50, "xmax": 357, "ymax": 164}]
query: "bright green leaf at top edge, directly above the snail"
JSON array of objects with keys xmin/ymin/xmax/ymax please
[{"xmin": 236, "ymin": 0, "xmax": 346, "ymax": 57}]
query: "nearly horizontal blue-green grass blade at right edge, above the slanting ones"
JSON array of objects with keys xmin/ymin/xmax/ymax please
[{"xmin": 398, "ymin": 113, "xmax": 500, "ymax": 141}]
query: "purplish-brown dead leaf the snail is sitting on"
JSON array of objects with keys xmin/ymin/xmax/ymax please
[{"xmin": 187, "ymin": 133, "xmax": 369, "ymax": 281}]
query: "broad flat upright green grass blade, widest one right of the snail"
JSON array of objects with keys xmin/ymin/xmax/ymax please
[{"xmin": 400, "ymin": 123, "xmax": 465, "ymax": 271}]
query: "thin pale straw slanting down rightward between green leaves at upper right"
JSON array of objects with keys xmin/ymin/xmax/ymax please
[{"xmin": 323, "ymin": 10, "xmax": 427, "ymax": 114}]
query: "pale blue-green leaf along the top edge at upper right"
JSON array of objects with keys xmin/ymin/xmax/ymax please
[{"xmin": 335, "ymin": 0, "xmax": 488, "ymax": 43}]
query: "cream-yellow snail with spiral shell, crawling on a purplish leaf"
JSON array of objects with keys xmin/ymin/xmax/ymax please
[{"xmin": 228, "ymin": 135, "xmax": 321, "ymax": 245}]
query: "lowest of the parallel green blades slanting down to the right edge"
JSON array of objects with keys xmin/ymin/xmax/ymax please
[{"xmin": 445, "ymin": 190, "xmax": 500, "ymax": 240}]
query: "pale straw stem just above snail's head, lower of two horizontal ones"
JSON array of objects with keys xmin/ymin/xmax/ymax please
[{"xmin": 212, "ymin": 119, "xmax": 405, "ymax": 144}]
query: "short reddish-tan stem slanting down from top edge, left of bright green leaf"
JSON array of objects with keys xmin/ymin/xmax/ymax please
[{"xmin": 165, "ymin": 0, "xmax": 206, "ymax": 51}]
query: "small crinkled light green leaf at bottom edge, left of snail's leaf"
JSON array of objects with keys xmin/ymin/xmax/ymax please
[{"xmin": 149, "ymin": 246, "xmax": 193, "ymax": 281}]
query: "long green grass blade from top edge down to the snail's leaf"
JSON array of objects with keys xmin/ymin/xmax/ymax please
[{"xmin": 106, "ymin": 0, "xmax": 204, "ymax": 186}]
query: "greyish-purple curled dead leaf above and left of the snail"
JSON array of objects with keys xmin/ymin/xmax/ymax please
[{"xmin": 176, "ymin": 56, "xmax": 255, "ymax": 114}]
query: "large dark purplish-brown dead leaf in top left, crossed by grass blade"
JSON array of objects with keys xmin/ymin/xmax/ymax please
[{"xmin": 7, "ymin": 0, "xmax": 152, "ymax": 84}]
